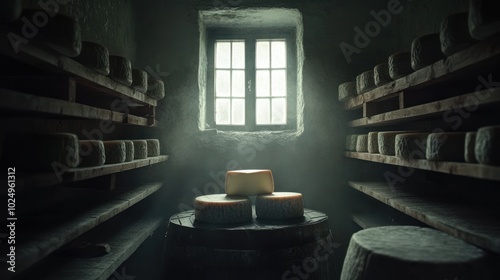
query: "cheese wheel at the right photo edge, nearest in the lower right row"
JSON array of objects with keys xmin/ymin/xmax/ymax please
[{"xmin": 474, "ymin": 126, "xmax": 500, "ymax": 165}]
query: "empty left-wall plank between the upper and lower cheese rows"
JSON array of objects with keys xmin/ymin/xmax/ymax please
[{"xmin": 0, "ymin": 88, "xmax": 150, "ymax": 126}]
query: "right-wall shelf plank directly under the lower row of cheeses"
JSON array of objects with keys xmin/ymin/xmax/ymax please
[{"xmin": 345, "ymin": 152, "xmax": 500, "ymax": 181}]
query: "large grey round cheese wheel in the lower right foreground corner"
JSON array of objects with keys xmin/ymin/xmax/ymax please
[{"xmin": 340, "ymin": 226, "xmax": 490, "ymax": 280}]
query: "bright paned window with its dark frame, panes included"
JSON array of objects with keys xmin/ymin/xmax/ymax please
[{"xmin": 207, "ymin": 29, "xmax": 296, "ymax": 131}]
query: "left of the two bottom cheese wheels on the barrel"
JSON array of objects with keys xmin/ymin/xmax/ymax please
[{"xmin": 194, "ymin": 194, "xmax": 252, "ymax": 224}]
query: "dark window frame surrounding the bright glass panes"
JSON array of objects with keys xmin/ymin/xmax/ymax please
[{"xmin": 206, "ymin": 28, "xmax": 297, "ymax": 132}]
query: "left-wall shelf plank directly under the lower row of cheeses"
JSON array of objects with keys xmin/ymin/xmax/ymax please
[{"xmin": 16, "ymin": 155, "xmax": 169, "ymax": 190}]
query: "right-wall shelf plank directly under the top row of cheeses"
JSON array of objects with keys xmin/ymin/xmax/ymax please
[{"xmin": 344, "ymin": 37, "xmax": 500, "ymax": 110}]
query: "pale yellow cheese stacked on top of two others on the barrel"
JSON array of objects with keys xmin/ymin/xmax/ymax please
[{"xmin": 225, "ymin": 169, "xmax": 274, "ymax": 196}]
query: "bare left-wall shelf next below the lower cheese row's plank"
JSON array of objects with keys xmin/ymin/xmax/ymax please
[{"xmin": 0, "ymin": 183, "xmax": 162, "ymax": 279}]
